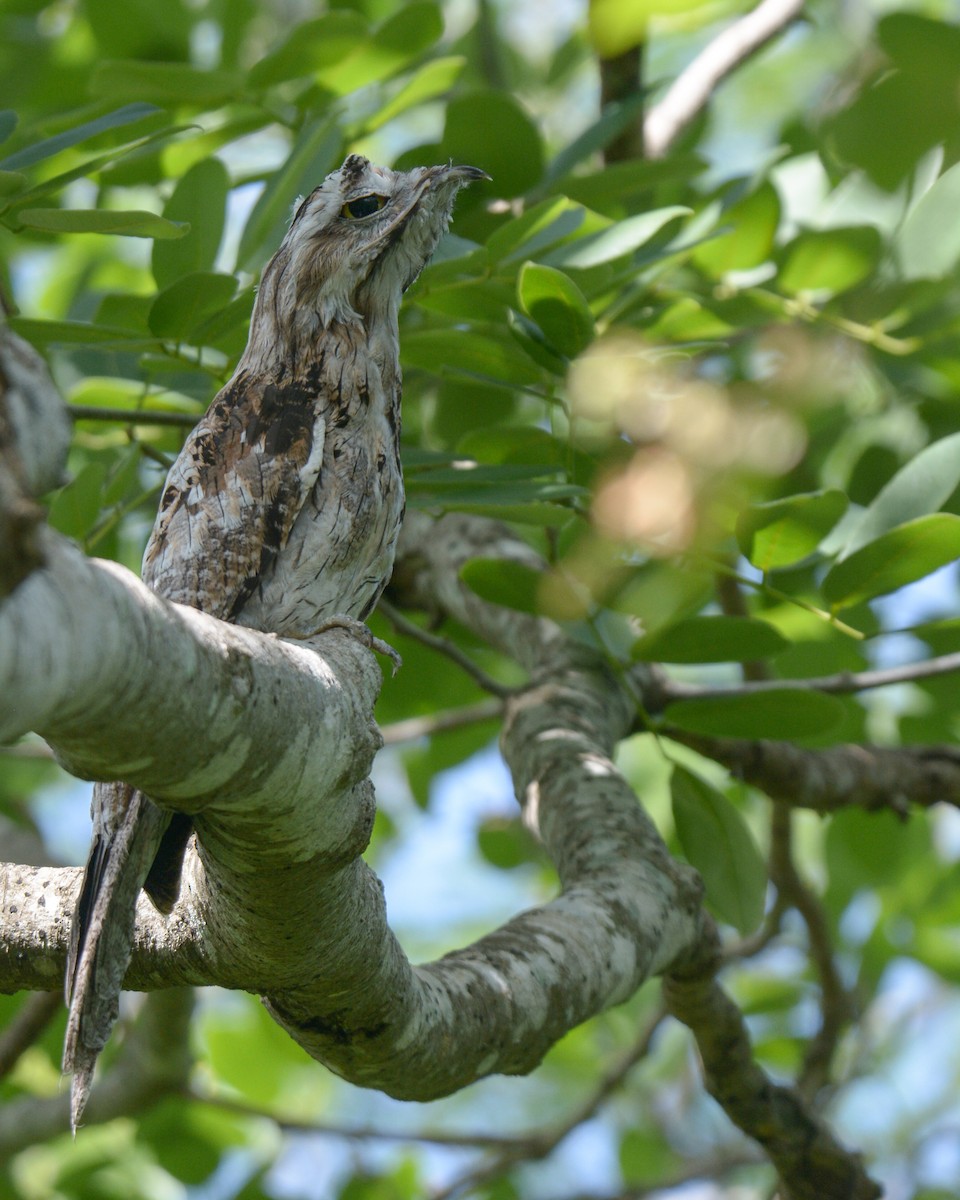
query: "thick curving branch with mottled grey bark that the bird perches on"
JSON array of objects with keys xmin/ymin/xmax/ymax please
[{"xmin": 0, "ymin": 316, "xmax": 877, "ymax": 1200}]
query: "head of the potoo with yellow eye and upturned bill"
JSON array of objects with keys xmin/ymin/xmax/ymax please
[{"xmin": 254, "ymin": 154, "xmax": 490, "ymax": 341}]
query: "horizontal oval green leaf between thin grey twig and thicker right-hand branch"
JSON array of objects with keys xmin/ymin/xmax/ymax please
[{"xmin": 666, "ymin": 688, "xmax": 846, "ymax": 738}]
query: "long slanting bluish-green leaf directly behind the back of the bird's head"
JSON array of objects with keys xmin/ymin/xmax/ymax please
[{"xmin": 236, "ymin": 118, "xmax": 341, "ymax": 268}]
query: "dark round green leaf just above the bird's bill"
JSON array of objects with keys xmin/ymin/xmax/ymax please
[{"xmin": 439, "ymin": 90, "xmax": 544, "ymax": 197}]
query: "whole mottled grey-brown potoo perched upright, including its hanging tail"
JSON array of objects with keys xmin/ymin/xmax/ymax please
[{"xmin": 64, "ymin": 155, "xmax": 486, "ymax": 1129}]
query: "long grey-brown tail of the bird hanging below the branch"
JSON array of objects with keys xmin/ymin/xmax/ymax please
[{"xmin": 64, "ymin": 784, "xmax": 170, "ymax": 1133}]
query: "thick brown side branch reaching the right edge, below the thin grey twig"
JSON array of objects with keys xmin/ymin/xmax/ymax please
[{"xmin": 658, "ymin": 726, "xmax": 960, "ymax": 816}]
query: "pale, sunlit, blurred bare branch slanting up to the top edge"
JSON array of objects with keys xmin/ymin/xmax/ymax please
[{"xmin": 643, "ymin": 0, "xmax": 803, "ymax": 158}]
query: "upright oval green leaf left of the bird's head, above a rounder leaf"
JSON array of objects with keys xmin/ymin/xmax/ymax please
[{"xmin": 151, "ymin": 157, "xmax": 229, "ymax": 288}]
